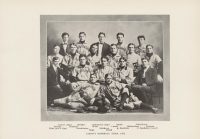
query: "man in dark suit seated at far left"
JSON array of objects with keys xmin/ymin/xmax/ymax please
[{"xmin": 47, "ymin": 57, "xmax": 65, "ymax": 105}]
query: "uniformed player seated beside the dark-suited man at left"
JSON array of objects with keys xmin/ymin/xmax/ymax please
[{"xmin": 72, "ymin": 55, "xmax": 93, "ymax": 82}]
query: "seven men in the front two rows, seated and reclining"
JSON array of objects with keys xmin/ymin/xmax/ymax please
[{"xmin": 47, "ymin": 55, "xmax": 158, "ymax": 113}]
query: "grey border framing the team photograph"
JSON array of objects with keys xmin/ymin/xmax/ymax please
[{"xmin": 40, "ymin": 15, "xmax": 170, "ymax": 121}]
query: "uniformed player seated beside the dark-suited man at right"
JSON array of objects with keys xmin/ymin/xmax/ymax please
[{"xmin": 114, "ymin": 57, "xmax": 134, "ymax": 84}]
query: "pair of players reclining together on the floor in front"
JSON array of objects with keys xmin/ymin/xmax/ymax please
[{"xmin": 54, "ymin": 74, "xmax": 157, "ymax": 113}]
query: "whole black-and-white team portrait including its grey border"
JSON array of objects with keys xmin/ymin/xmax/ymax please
[{"xmin": 40, "ymin": 15, "xmax": 170, "ymax": 121}]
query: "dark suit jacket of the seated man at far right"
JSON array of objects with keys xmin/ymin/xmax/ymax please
[{"xmin": 134, "ymin": 67, "xmax": 157, "ymax": 86}]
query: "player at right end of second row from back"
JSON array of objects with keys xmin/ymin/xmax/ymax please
[{"xmin": 146, "ymin": 44, "xmax": 163, "ymax": 83}]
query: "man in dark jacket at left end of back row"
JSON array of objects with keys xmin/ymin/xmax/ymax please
[{"xmin": 60, "ymin": 32, "xmax": 70, "ymax": 56}]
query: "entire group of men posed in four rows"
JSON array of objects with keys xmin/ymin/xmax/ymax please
[{"xmin": 47, "ymin": 32, "xmax": 163, "ymax": 113}]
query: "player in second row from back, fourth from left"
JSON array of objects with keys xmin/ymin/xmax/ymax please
[{"xmin": 107, "ymin": 44, "xmax": 121, "ymax": 69}]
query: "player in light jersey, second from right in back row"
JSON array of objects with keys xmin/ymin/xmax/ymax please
[{"xmin": 116, "ymin": 32, "xmax": 127, "ymax": 56}]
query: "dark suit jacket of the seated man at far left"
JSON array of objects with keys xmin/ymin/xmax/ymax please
[{"xmin": 47, "ymin": 66, "xmax": 62, "ymax": 87}]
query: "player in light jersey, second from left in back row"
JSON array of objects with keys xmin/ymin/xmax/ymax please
[{"xmin": 76, "ymin": 32, "xmax": 89, "ymax": 56}]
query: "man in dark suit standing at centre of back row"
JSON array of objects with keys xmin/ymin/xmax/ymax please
[{"xmin": 91, "ymin": 32, "xmax": 110, "ymax": 57}]
